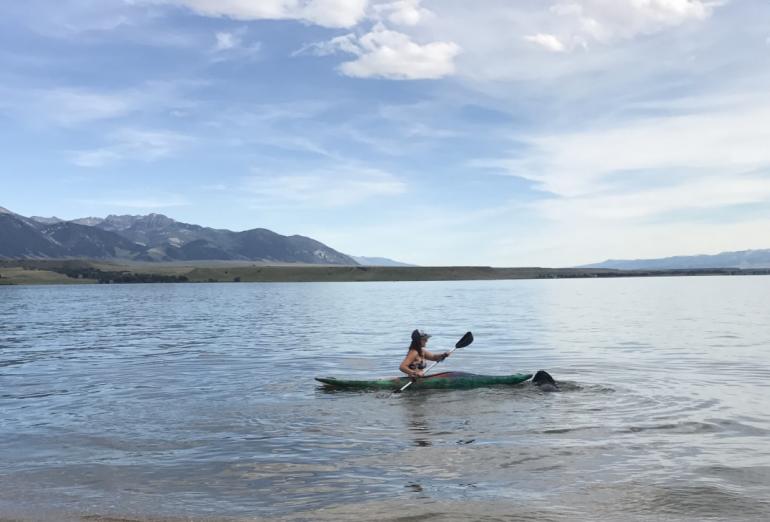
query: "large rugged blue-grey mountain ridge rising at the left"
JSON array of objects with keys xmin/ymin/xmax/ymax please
[{"xmin": 0, "ymin": 207, "xmax": 358, "ymax": 265}]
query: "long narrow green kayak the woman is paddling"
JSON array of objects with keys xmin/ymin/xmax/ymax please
[{"xmin": 315, "ymin": 372, "xmax": 532, "ymax": 390}]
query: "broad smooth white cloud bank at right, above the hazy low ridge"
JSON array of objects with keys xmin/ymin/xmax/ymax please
[{"xmin": 471, "ymin": 94, "xmax": 770, "ymax": 244}]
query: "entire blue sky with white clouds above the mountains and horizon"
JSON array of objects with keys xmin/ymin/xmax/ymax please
[{"xmin": 0, "ymin": 0, "xmax": 770, "ymax": 266}]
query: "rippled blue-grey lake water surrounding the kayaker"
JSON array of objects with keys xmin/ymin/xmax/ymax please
[{"xmin": 0, "ymin": 276, "xmax": 770, "ymax": 521}]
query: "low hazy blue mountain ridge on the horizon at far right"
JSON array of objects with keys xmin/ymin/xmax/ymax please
[{"xmin": 577, "ymin": 249, "xmax": 770, "ymax": 270}]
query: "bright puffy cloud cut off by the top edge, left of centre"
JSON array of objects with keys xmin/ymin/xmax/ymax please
[{"xmin": 156, "ymin": 0, "xmax": 368, "ymax": 27}]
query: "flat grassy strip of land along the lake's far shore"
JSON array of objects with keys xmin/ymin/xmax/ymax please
[{"xmin": 0, "ymin": 259, "xmax": 770, "ymax": 285}]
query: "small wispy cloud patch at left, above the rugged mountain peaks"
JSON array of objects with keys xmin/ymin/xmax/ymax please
[{"xmin": 70, "ymin": 129, "xmax": 193, "ymax": 168}]
